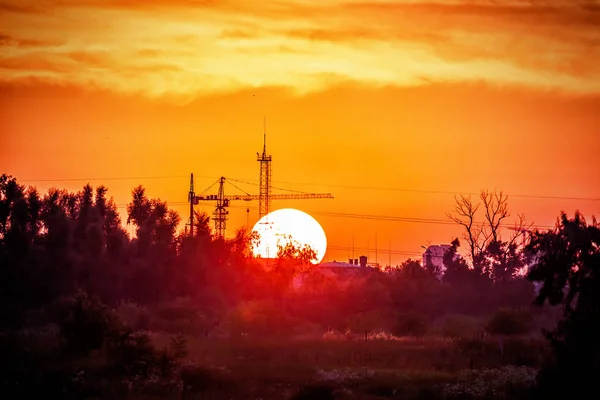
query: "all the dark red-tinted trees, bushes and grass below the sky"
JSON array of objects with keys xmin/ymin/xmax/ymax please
[{"xmin": 0, "ymin": 175, "xmax": 599, "ymax": 399}]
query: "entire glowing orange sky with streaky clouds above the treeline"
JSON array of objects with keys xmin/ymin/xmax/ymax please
[{"xmin": 0, "ymin": 0, "xmax": 600, "ymax": 263}]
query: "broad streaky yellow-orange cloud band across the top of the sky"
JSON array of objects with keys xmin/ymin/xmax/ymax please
[{"xmin": 0, "ymin": 0, "xmax": 600, "ymax": 98}]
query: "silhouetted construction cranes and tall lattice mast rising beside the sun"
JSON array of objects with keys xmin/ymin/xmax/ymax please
[{"xmin": 188, "ymin": 126, "xmax": 333, "ymax": 238}]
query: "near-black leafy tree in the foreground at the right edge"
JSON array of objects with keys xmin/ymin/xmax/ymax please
[{"xmin": 528, "ymin": 212, "xmax": 600, "ymax": 398}]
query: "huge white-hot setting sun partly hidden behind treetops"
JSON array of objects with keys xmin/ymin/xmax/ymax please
[{"xmin": 252, "ymin": 208, "xmax": 327, "ymax": 264}]
